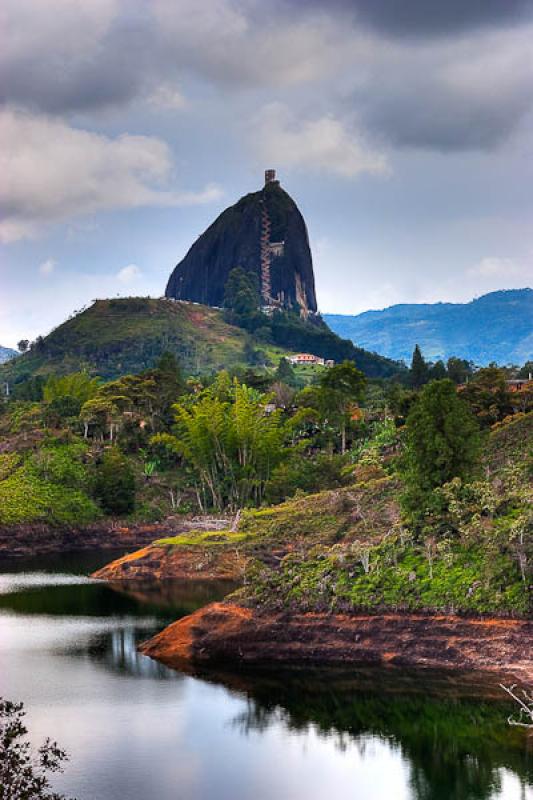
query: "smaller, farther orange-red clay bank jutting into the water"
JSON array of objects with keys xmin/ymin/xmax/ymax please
[{"xmin": 92, "ymin": 544, "xmax": 243, "ymax": 581}]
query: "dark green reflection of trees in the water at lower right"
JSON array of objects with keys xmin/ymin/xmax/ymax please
[{"xmin": 224, "ymin": 671, "xmax": 533, "ymax": 800}]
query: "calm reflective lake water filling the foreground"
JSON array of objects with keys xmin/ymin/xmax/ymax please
[{"xmin": 0, "ymin": 552, "xmax": 533, "ymax": 800}]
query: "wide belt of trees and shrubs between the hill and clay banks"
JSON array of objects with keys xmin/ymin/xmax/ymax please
[{"xmin": 0, "ymin": 324, "xmax": 533, "ymax": 615}]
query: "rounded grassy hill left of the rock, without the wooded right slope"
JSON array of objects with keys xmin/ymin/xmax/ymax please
[{"xmin": 0, "ymin": 297, "xmax": 246, "ymax": 380}]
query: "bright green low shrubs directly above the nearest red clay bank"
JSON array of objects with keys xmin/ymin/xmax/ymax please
[{"xmin": 246, "ymin": 537, "xmax": 530, "ymax": 616}]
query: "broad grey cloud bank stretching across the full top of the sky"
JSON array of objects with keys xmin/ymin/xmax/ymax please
[{"xmin": 0, "ymin": 0, "xmax": 533, "ymax": 156}]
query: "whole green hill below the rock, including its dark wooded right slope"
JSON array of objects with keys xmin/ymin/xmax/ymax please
[{"xmin": 0, "ymin": 297, "xmax": 398, "ymax": 381}]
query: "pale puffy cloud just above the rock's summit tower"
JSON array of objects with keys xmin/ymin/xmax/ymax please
[{"xmin": 252, "ymin": 103, "xmax": 388, "ymax": 178}]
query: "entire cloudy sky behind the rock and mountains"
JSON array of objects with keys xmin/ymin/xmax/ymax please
[{"xmin": 0, "ymin": 0, "xmax": 533, "ymax": 346}]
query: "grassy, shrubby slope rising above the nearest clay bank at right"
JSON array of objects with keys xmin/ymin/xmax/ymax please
[{"xmin": 239, "ymin": 414, "xmax": 533, "ymax": 616}]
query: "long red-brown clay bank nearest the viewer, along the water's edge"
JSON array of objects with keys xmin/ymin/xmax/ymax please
[{"xmin": 139, "ymin": 603, "xmax": 533, "ymax": 684}]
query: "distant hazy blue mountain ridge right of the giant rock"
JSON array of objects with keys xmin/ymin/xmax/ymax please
[{"xmin": 324, "ymin": 289, "xmax": 533, "ymax": 365}]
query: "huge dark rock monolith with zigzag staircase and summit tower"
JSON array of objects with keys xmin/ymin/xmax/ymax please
[{"xmin": 165, "ymin": 169, "xmax": 317, "ymax": 316}]
